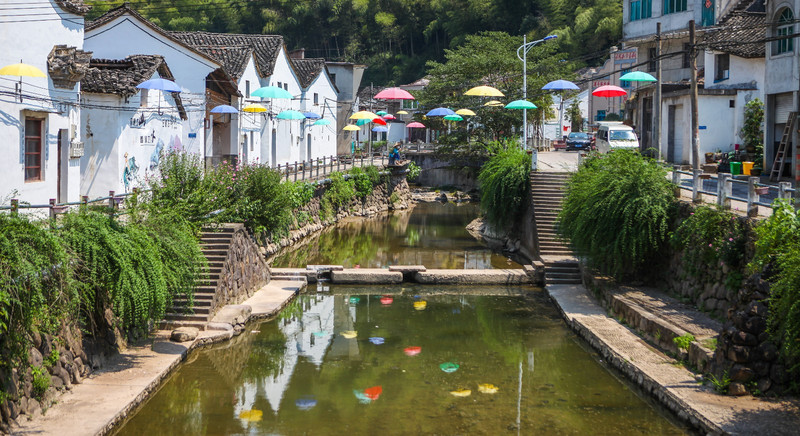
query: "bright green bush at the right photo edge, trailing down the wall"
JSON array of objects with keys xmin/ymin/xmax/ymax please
[{"xmin": 750, "ymin": 200, "xmax": 800, "ymax": 380}]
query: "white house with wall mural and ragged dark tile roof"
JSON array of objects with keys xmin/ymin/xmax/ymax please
[{"xmin": 80, "ymin": 55, "xmax": 187, "ymax": 198}]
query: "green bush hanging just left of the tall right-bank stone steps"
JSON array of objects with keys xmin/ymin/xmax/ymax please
[{"xmin": 478, "ymin": 147, "xmax": 531, "ymax": 227}]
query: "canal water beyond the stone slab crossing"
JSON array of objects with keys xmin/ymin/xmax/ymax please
[{"xmin": 272, "ymin": 203, "xmax": 522, "ymax": 269}]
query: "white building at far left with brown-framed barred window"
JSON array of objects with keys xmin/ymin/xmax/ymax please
[{"xmin": 0, "ymin": 0, "xmax": 91, "ymax": 204}]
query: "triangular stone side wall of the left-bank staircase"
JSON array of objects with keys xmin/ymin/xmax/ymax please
[{"xmin": 212, "ymin": 224, "xmax": 270, "ymax": 312}]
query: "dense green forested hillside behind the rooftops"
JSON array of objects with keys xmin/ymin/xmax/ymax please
[{"xmin": 89, "ymin": 0, "xmax": 622, "ymax": 85}]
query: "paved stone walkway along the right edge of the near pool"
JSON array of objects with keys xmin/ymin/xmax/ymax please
[{"xmin": 546, "ymin": 285, "xmax": 800, "ymax": 435}]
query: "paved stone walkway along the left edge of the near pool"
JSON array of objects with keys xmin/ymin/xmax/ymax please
[{"xmin": 13, "ymin": 280, "xmax": 305, "ymax": 436}]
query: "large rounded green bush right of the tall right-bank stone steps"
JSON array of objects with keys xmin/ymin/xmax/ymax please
[{"xmin": 557, "ymin": 150, "xmax": 676, "ymax": 279}]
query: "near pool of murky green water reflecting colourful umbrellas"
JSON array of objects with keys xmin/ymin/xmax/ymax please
[{"xmin": 120, "ymin": 286, "xmax": 683, "ymax": 435}]
